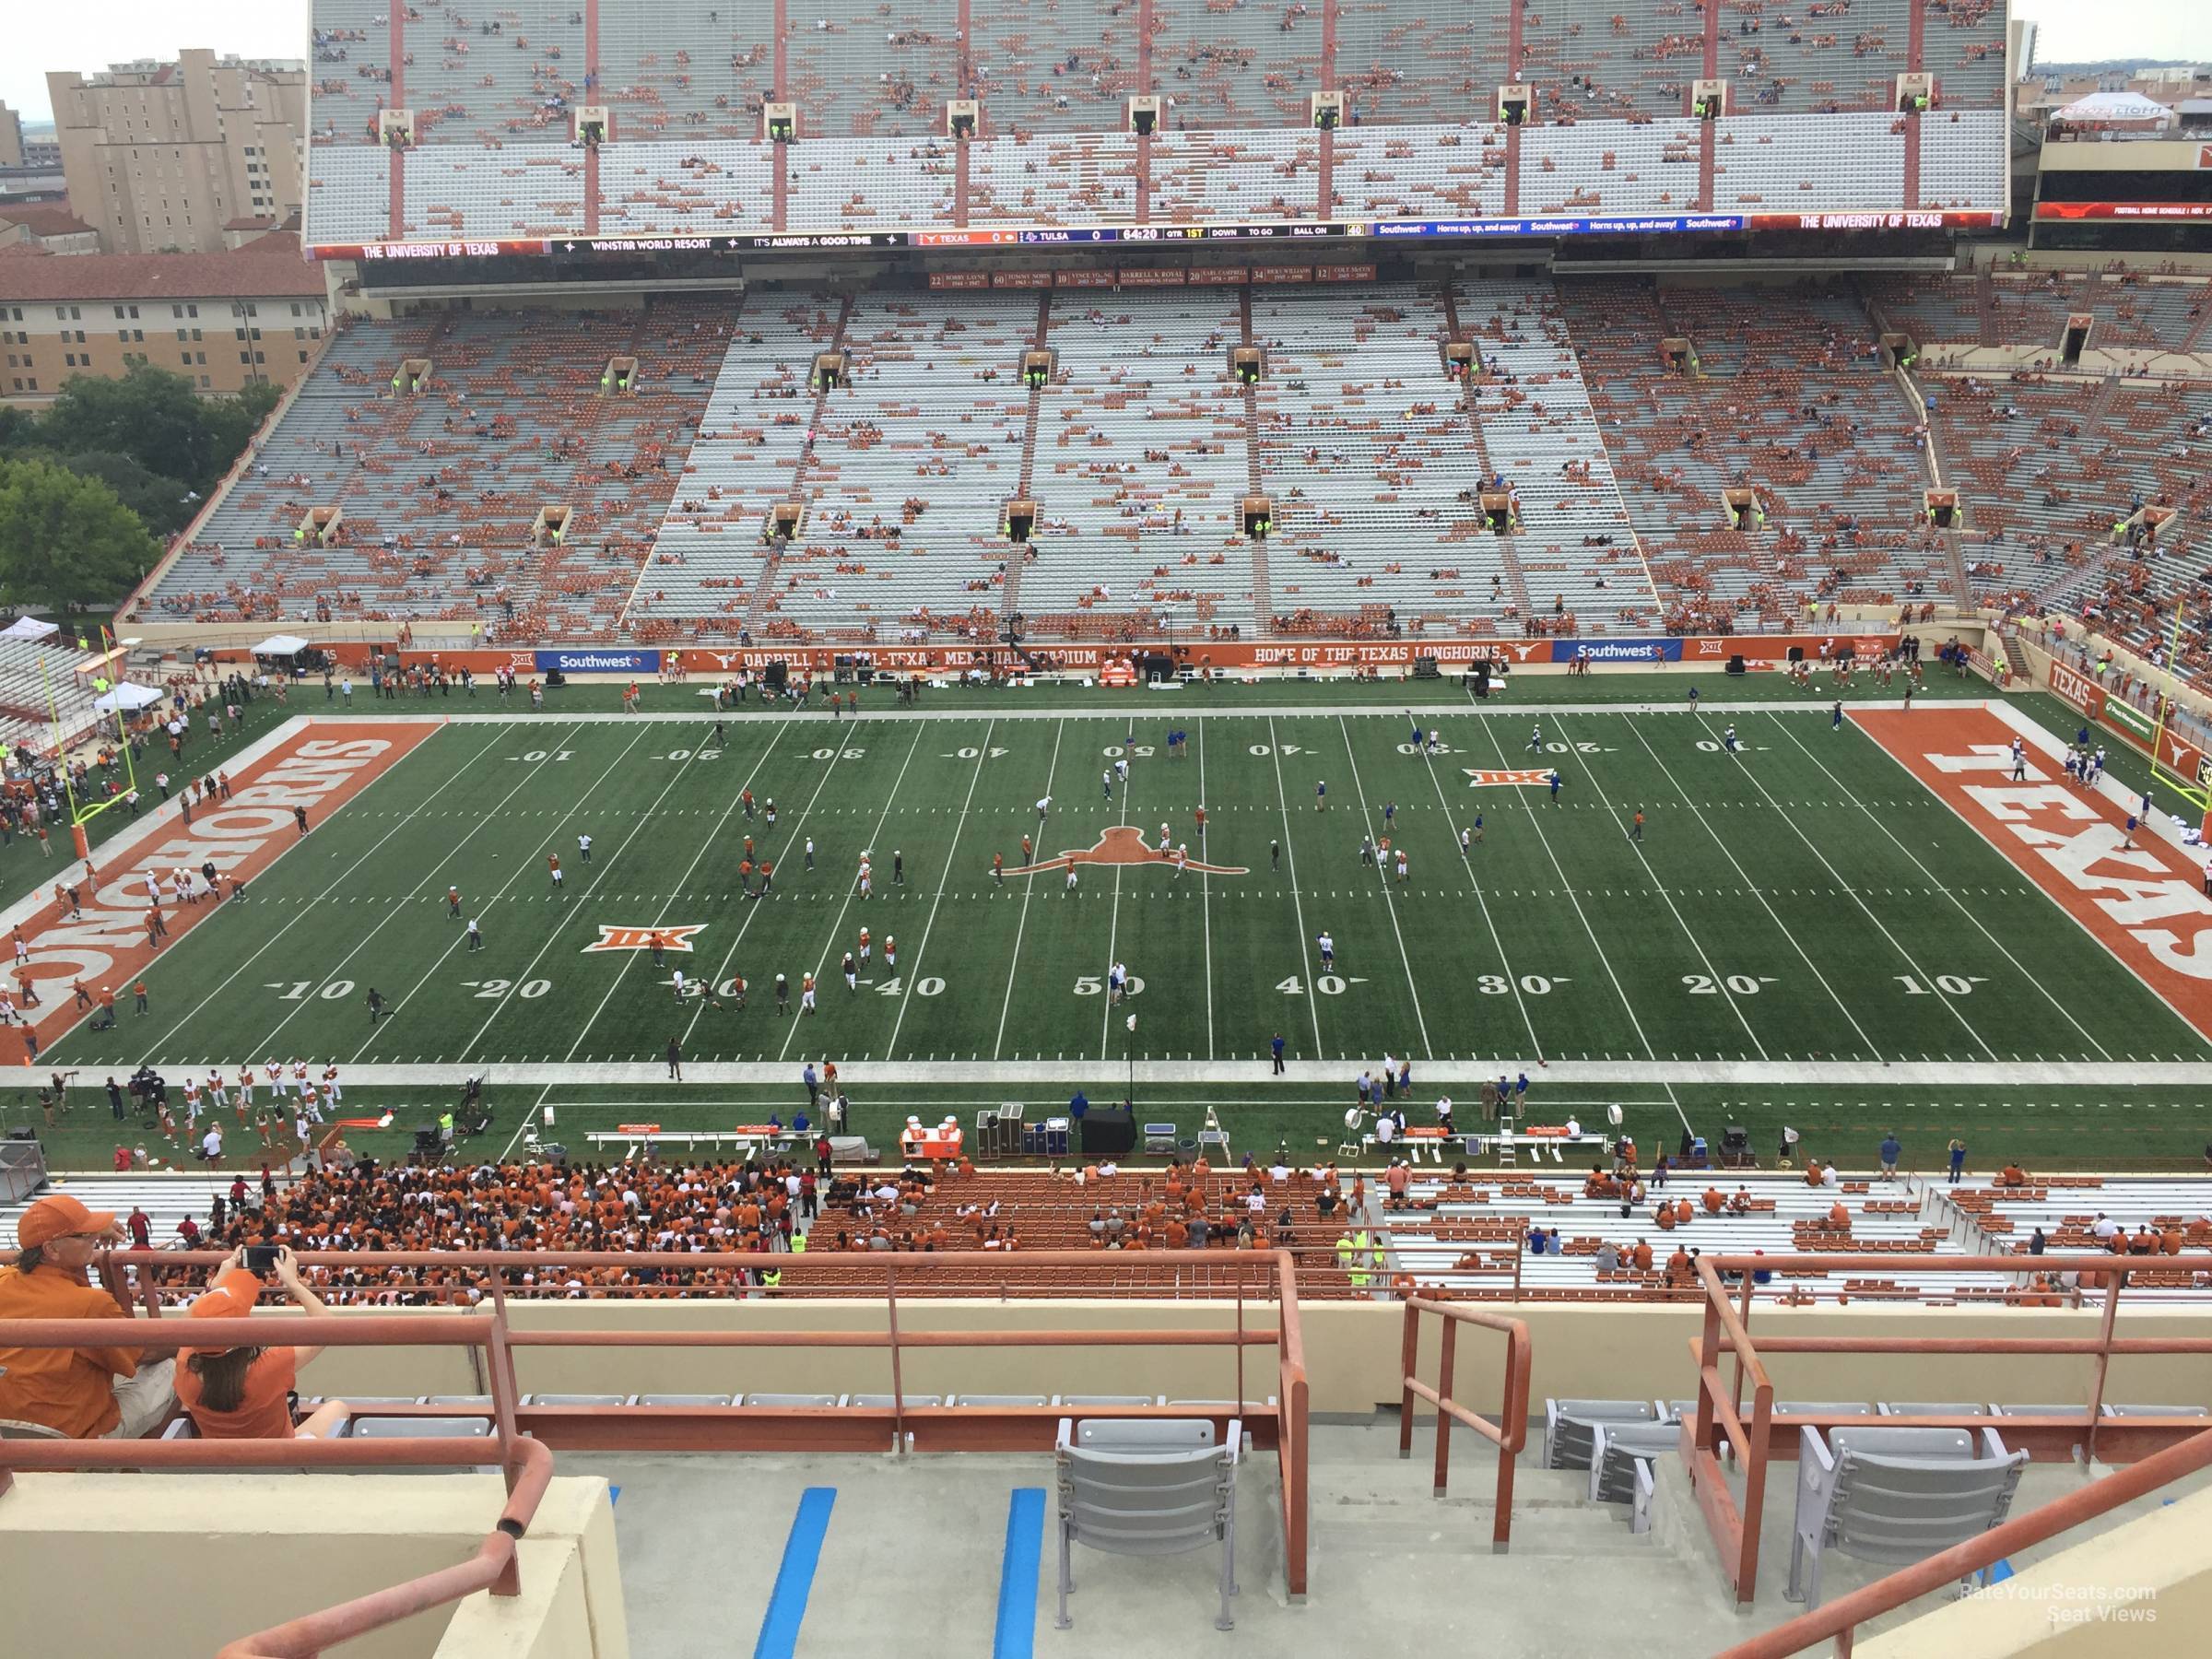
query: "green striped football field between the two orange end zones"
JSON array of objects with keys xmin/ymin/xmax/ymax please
[{"xmin": 49, "ymin": 697, "xmax": 2212, "ymax": 1093}]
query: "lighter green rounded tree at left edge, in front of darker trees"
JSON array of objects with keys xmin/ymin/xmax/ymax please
[{"xmin": 0, "ymin": 460, "xmax": 161, "ymax": 613}]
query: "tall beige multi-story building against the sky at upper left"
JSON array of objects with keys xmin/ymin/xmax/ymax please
[{"xmin": 46, "ymin": 49, "xmax": 308, "ymax": 254}]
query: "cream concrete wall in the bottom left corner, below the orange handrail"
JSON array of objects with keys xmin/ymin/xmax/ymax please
[{"xmin": 0, "ymin": 1473, "xmax": 629, "ymax": 1659}]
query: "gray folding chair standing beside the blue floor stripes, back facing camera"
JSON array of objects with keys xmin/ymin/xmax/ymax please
[{"xmin": 1055, "ymin": 1418, "xmax": 1243, "ymax": 1630}]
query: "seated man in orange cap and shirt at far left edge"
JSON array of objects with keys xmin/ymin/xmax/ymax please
[{"xmin": 0, "ymin": 1194, "xmax": 177, "ymax": 1440}]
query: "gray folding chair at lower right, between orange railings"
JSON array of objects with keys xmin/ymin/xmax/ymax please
[{"xmin": 1785, "ymin": 1429, "xmax": 2029, "ymax": 1606}]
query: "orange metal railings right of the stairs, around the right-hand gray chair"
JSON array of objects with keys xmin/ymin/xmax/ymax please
[{"xmin": 1681, "ymin": 1254, "xmax": 2212, "ymax": 1618}]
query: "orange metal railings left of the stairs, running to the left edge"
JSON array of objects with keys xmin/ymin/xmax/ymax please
[{"xmin": 0, "ymin": 1250, "xmax": 1312, "ymax": 1659}]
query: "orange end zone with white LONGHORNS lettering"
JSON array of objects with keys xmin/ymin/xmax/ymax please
[{"xmin": 0, "ymin": 721, "xmax": 438, "ymax": 1064}]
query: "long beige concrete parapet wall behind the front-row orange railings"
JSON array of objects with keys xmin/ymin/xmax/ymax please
[{"xmin": 272, "ymin": 1299, "xmax": 2212, "ymax": 1416}]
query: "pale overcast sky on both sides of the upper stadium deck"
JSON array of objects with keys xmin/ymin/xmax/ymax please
[{"xmin": 0, "ymin": 0, "xmax": 2212, "ymax": 122}]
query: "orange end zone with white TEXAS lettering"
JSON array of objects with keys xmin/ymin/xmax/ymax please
[{"xmin": 1852, "ymin": 706, "xmax": 2212, "ymax": 1035}]
